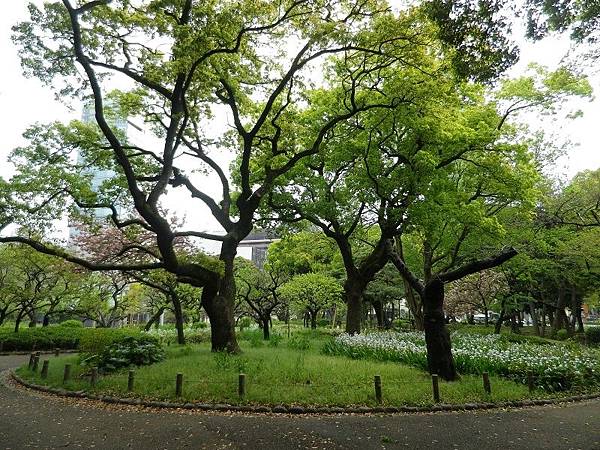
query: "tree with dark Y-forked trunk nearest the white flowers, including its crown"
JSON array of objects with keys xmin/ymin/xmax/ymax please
[{"xmin": 390, "ymin": 66, "xmax": 591, "ymax": 379}]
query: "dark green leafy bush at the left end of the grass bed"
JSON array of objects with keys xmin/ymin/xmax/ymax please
[{"xmin": 82, "ymin": 334, "xmax": 165, "ymax": 373}]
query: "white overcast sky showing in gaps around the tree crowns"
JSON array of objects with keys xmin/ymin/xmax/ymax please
[{"xmin": 0, "ymin": 0, "xmax": 600, "ymax": 251}]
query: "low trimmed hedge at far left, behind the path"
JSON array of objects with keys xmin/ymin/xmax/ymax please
[{"xmin": 0, "ymin": 326, "xmax": 149, "ymax": 353}]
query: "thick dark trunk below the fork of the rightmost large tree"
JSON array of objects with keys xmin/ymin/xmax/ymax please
[{"xmin": 422, "ymin": 278, "xmax": 458, "ymax": 381}]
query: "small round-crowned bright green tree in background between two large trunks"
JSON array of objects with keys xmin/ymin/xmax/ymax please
[{"xmin": 279, "ymin": 273, "xmax": 344, "ymax": 329}]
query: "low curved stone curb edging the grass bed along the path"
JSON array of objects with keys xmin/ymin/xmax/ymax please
[{"xmin": 9, "ymin": 370, "xmax": 600, "ymax": 415}]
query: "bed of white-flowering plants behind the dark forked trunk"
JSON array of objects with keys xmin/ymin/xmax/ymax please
[{"xmin": 323, "ymin": 332, "xmax": 600, "ymax": 391}]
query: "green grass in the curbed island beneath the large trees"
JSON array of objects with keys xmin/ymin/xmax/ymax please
[{"xmin": 17, "ymin": 338, "xmax": 541, "ymax": 406}]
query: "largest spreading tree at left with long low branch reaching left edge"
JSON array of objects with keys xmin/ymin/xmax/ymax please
[{"xmin": 1, "ymin": 0, "xmax": 424, "ymax": 352}]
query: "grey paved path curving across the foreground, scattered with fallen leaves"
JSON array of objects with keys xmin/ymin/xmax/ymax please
[{"xmin": 0, "ymin": 356, "xmax": 600, "ymax": 450}]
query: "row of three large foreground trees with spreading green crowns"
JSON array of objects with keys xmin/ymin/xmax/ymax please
[{"xmin": 0, "ymin": 0, "xmax": 591, "ymax": 379}]
